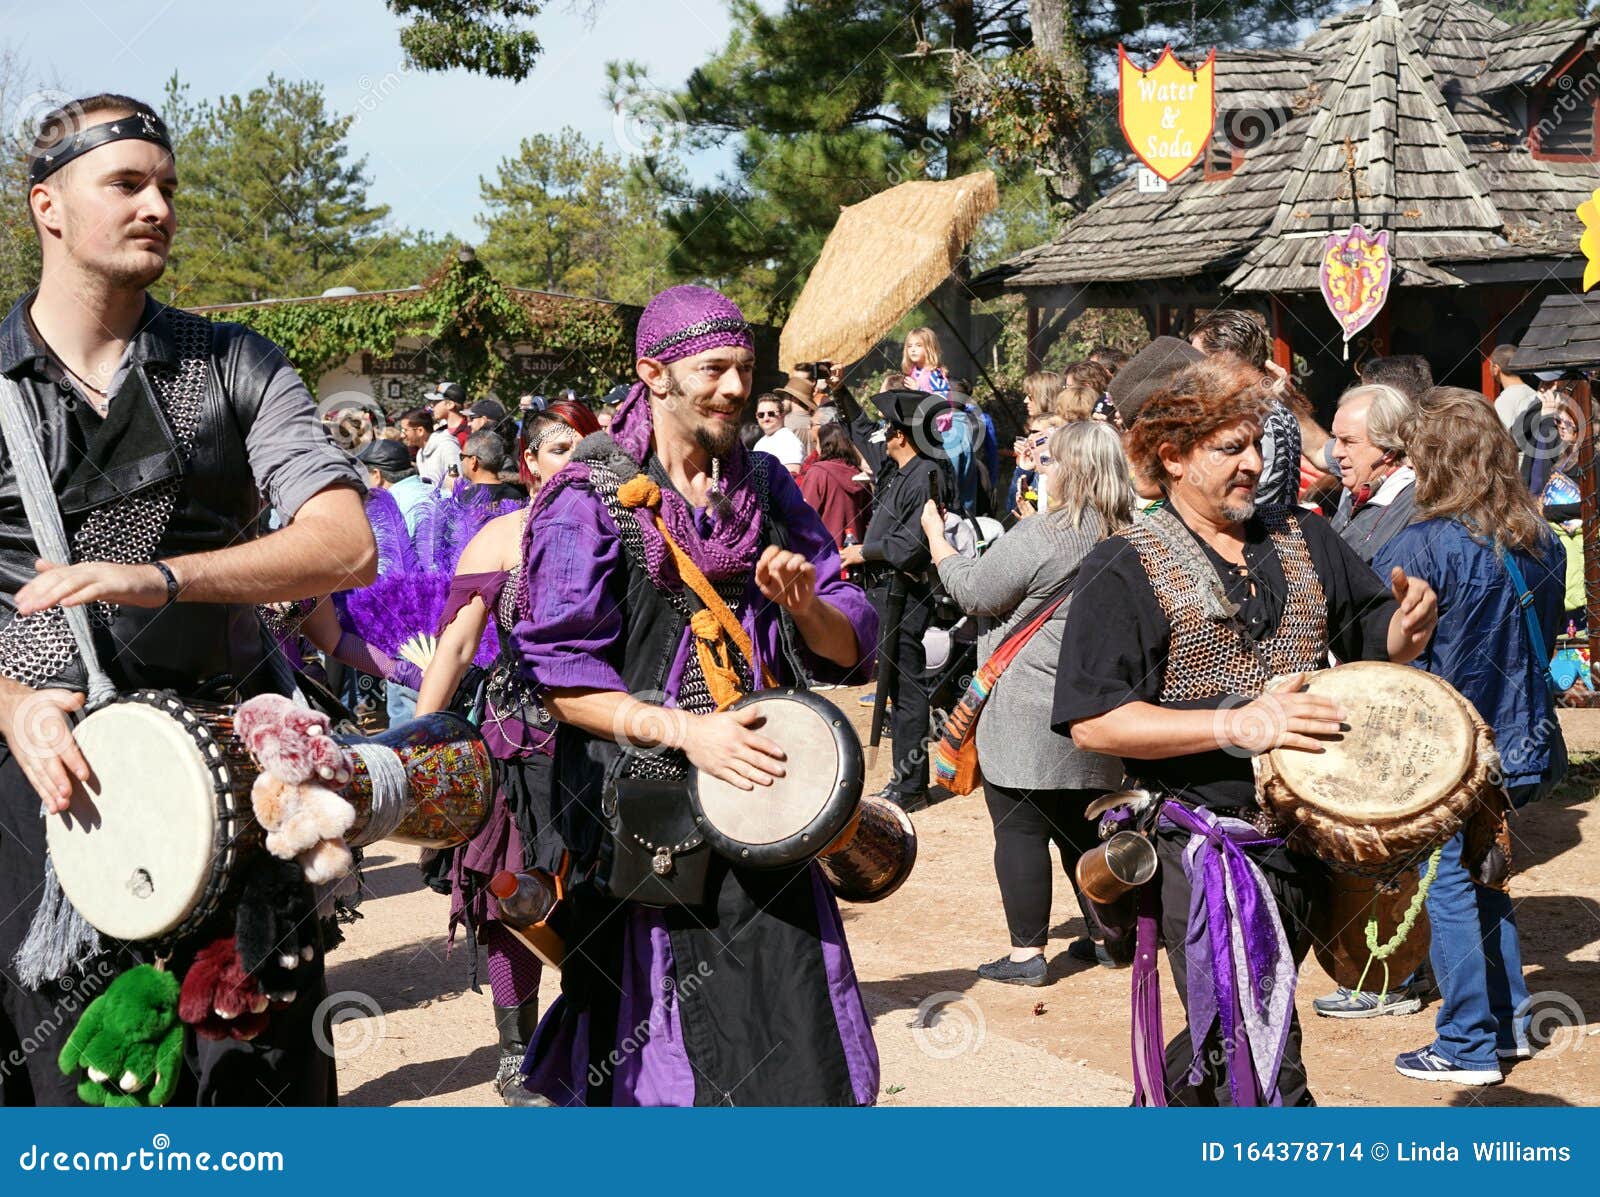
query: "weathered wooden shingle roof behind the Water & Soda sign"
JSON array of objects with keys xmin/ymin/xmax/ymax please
[{"xmin": 974, "ymin": 0, "xmax": 1600, "ymax": 293}]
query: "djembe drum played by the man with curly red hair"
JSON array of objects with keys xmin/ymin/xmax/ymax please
[{"xmin": 1254, "ymin": 661, "xmax": 1506, "ymax": 987}]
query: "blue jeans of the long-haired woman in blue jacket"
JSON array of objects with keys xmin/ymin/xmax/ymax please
[{"xmin": 1427, "ymin": 835, "xmax": 1528, "ymax": 1069}]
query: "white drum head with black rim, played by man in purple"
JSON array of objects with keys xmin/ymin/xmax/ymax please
[{"xmin": 691, "ymin": 690, "xmax": 866, "ymax": 867}]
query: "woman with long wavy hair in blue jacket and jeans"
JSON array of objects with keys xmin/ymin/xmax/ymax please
[{"xmin": 1373, "ymin": 387, "xmax": 1566, "ymax": 1085}]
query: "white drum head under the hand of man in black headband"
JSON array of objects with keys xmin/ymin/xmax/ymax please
[{"xmin": 45, "ymin": 703, "xmax": 218, "ymax": 941}]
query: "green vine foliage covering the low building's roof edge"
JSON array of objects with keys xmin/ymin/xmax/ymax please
[{"xmin": 205, "ymin": 254, "xmax": 638, "ymax": 398}]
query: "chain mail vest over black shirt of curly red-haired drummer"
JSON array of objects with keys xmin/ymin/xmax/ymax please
[{"xmin": 1117, "ymin": 507, "xmax": 1328, "ymax": 703}]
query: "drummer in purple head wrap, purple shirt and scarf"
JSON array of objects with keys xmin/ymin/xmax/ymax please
[{"xmin": 515, "ymin": 286, "xmax": 878, "ymax": 1106}]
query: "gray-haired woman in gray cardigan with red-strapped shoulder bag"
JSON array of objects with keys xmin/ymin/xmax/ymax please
[{"xmin": 922, "ymin": 421, "xmax": 1133, "ymax": 986}]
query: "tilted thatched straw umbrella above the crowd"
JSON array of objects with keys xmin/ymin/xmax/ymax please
[{"xmin": 778, "ymin": 171, "xmax": 1000, "ymax": 368}]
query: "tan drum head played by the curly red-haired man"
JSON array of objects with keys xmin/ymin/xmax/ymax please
[{"xmin": 1270, "ymin": 661, "xmax": 1475, "ymax": 823}]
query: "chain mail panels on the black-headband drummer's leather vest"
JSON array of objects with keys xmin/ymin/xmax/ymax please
[{"xmin": 0, "ymin": 307, "xmax": 213, "ymax": 687}]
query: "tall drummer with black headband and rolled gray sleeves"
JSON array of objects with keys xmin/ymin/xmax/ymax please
[{"xmin": 0, "ymin": 94, "xmax": 376, "ymax": 1106}]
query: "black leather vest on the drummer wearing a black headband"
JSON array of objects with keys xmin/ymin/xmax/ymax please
[{"xmin": 0, "ymin": 294, "xmax": 283, "ymax": 695}]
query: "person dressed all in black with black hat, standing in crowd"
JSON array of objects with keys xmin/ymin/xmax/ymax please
[{"xmin": 840, "ymin": 390, "xmax": 942, "ymax": 810}]
